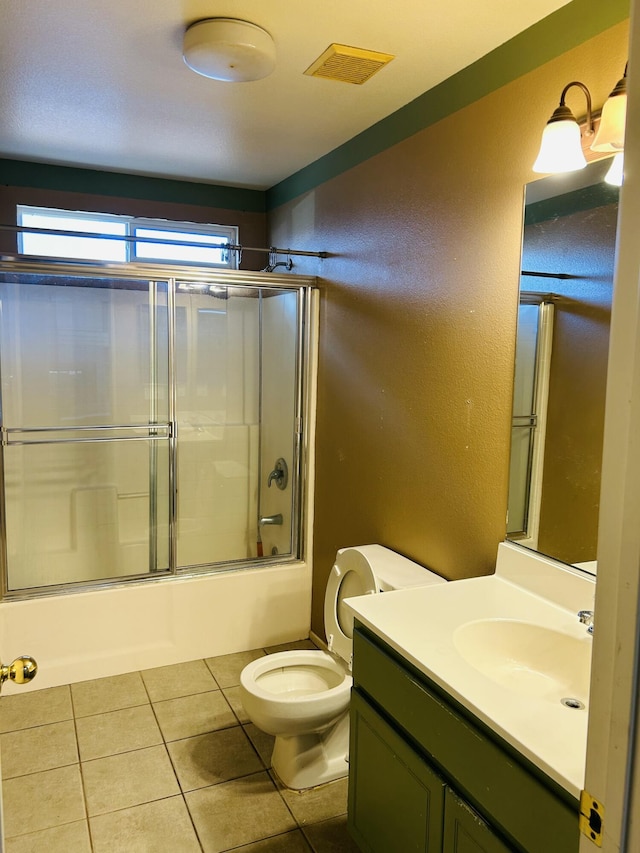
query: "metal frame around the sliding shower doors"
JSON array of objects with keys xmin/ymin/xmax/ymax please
[{"xmin": 0, "ymin": 257, "xmax": 318, "ymax": 601}]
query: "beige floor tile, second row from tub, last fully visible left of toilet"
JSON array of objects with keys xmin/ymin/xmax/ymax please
[{"xmin": 153, "ymin": 690, "xmax": 238, "ymax": 741}]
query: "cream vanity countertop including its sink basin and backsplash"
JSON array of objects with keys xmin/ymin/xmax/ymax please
[{"xmin": 345, "ymin": 544, "xmax": 595, "ymax": 798}]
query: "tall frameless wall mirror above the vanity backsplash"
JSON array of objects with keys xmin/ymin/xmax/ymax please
[{"xmin": 507, "ymin": 158, "xmax": 619, "ymax": 572}]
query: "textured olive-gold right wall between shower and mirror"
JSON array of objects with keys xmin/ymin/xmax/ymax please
[{"xmin": 270, "ymin": 23, "xmax": 628, "ymax": 635}]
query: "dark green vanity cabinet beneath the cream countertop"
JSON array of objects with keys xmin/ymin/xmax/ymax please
[{"xmin": 348, "ymin": 623, "xmax": 579, "ymax": 853}]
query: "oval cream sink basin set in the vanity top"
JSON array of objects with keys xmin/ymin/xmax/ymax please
[{"xmin": 453, "ymin": 619, "xmax": 592, "ymax": 705}]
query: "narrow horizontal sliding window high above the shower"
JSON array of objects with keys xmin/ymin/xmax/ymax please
[{"xmin": 17, "ymin": 205, "xmax": 238, "ymax": 269}]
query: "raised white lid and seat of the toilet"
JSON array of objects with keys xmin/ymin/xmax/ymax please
[{"xmin": 324, "ymin": 548, "xmax": 379, "ymax": 665}]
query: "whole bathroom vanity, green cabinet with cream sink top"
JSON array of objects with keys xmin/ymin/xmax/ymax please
[{"xmin": 348, "ymin": 545, "xmax": 595, "ymax": 853}]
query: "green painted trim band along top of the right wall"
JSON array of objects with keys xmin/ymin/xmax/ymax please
[{"xmin": 267, "ymin": 0, "xmax": 629, "ymax": 210}]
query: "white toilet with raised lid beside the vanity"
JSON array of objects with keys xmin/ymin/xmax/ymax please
[{"xmin": 240, "ymin": 545, "xmax": 445, "ymax": 790}]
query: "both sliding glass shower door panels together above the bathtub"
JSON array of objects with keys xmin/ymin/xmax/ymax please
[{"xmin": 0, "ymin": 268, "xmax": 305, "ymax": 595}]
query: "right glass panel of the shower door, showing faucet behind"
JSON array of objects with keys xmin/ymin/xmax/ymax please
[{"xmin": 175, "ymin": 282, "xmax": 302, "ymax": 569}]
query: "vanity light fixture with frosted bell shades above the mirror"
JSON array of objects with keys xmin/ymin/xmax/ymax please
[{"xmin": 533, "ymin": 67, "xmax": 627, "ymax": 174}]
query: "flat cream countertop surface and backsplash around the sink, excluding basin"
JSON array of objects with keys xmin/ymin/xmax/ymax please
[{"xmin": 346, "ymin": 546, "xmax": 595, "ymax": 798}]
